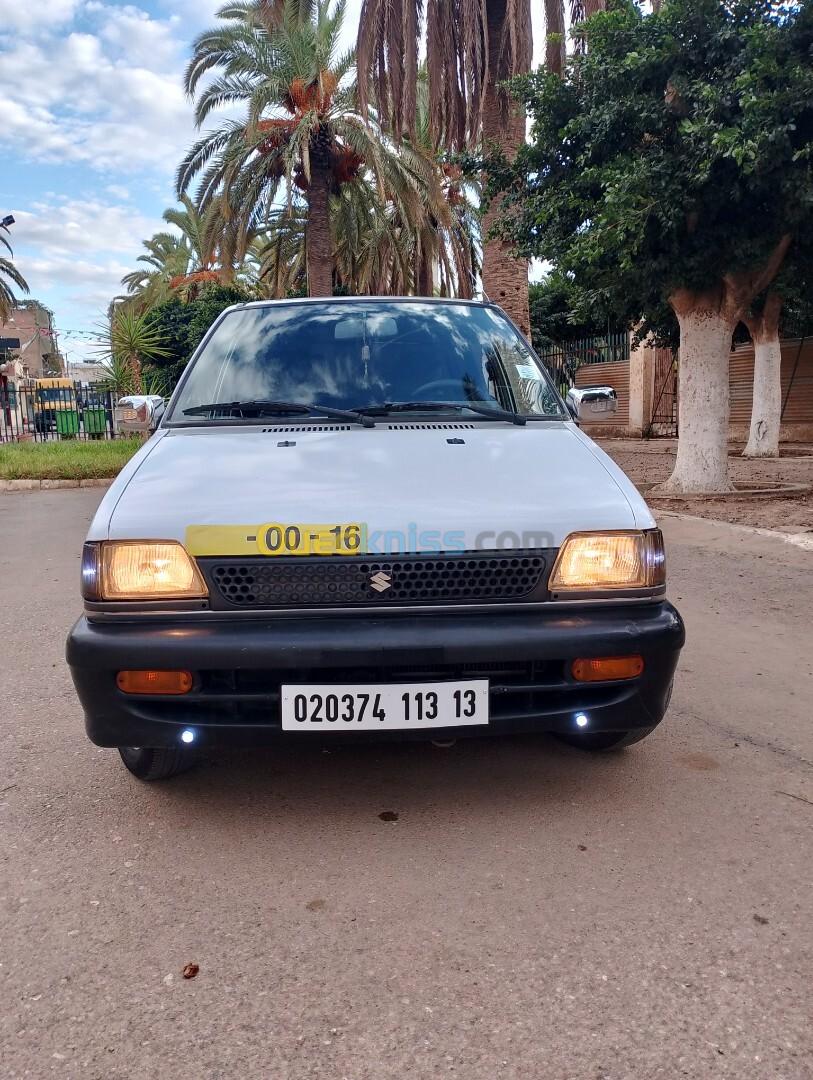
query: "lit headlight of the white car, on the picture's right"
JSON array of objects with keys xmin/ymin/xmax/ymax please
[{"xmin": 548, "ymin": 529, "xmax": 666, "ymax": 593}]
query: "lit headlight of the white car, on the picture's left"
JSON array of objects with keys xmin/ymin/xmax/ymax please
[{"xmin": 82, "ymin": 540, "xmax": 207, "ymax": 600}]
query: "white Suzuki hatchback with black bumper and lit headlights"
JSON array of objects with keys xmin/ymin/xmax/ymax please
[{"xmin": 67, "ymin": 298, "xmax": 685, "ymax": 780}]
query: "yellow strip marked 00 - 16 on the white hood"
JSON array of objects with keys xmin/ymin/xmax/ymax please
[{"xmin": 186, "ymin": 522, "xmax": 367, "ymax": 555}]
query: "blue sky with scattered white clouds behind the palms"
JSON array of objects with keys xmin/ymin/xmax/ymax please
[{"xmin": 0, "ymin": 0, "xmax": 542, "ymax": 362}]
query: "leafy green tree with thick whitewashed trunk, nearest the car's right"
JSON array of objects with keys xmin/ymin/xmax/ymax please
[{"xmin": 490, "ymin": 0, "xmax": 813, "ymax": 491}]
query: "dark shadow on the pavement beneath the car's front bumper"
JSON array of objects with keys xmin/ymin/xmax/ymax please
[{"xmin": 110, "ymin": 735, "xmax": 669, "ymax": 827}]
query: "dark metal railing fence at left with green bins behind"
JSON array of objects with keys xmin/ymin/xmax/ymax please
[{"xmin": 0, "ymin": 379, "xmax": 119, "ymax": 443}]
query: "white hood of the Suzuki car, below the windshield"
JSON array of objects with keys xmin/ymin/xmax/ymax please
[{"xmin": 91, "ymin": 421, "xmax": 654, "ymax": 554}]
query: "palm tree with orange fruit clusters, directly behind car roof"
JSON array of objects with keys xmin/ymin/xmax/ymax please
[{"xmin": 177, "ymin": 0, "xmax": 431, "ymax": 296}]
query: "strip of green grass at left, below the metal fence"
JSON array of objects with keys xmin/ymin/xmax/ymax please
[{"xmin": 0, "ymin": 438, "xmax": 144, "ymax": 480}]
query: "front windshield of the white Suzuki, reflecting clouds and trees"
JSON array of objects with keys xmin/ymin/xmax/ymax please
[{"xmin": 168, "ymin": 300, "xmax": 565, "ymax": 423}]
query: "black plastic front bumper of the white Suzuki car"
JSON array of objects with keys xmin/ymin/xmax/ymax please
[{"xmin": 67, "ymin": 603, "xmax": 685, "ymax": 746}]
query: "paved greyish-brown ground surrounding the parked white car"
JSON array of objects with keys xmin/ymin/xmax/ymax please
[{"xmin": 0, "ymin": 490, "xmax": 813, "ymax": 1080}]
